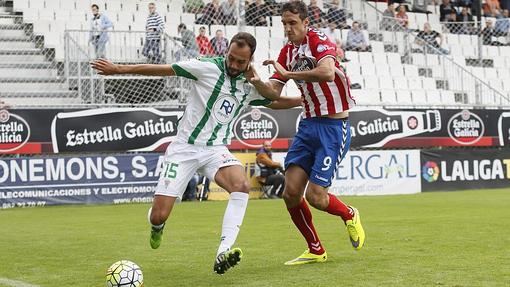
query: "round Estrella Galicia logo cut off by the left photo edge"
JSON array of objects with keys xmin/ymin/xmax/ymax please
[{"xmin": 0, "ymin": 110, "xmax": 30, "ymax": 152}]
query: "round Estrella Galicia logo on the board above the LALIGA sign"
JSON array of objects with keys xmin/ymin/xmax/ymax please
[{"xmin": 448, "ymin": 110, "xmax": 485, "ymax": 145}]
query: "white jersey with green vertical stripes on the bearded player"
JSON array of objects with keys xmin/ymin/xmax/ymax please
[{"xmin": 172, "ymin": 57, "xmax": 271, "ymax": 146}]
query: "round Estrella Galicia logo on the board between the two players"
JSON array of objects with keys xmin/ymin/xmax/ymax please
[{"xmin": 234, "ymin": 109, "xmax": 279, "ymax": 147}]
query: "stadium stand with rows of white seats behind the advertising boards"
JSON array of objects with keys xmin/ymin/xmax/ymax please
[{"xmin": 0, "ymin": 0, "xmax": 510, "ymax": 106}]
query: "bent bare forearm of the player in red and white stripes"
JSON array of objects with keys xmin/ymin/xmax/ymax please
[{"xmin": 264, "ymin": 57, "xmax": 335, "ymax": 82}]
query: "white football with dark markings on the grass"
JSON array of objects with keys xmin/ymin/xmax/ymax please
[{"xmin": 106, "ymin": 260, "xmax": 143, "ymax": 287}]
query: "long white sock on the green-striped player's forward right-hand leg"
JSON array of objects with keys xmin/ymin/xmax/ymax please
[{"xmin": 216, "ymin": 192, "xmax": 249, "ymax": 256}]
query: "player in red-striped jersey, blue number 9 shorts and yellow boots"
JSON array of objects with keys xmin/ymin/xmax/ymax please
[{"xmin": 257, "ymin": 1, "xmax": 365, "ymax": 265}]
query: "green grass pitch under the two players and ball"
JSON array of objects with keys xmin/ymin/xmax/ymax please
[{"xmin": 0, "ymin": 189, "xmax": 510, "ymax": 287}]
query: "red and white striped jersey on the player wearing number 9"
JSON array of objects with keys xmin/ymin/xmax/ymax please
[{"xmin": 270, "ymin": 28, "xmax": 356, "ymax": 118}]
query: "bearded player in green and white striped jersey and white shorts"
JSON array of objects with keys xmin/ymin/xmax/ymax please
[{"xmin": 92, "ymin": 32, "xmax": 301, "ymax": 274}]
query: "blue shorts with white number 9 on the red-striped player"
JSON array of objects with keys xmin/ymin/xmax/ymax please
[{"xmin": 285, "ymin": 118, "xmax": 351, "ymax": 187}]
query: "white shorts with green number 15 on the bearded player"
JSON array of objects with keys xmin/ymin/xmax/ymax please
[{"xmin": 155, "ymin": 142, "xmax": 242, "ymax": 199}]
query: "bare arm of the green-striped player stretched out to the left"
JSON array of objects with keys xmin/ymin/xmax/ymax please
[{"xmin": 90, "ymin": 59, "xmax": 175, "ymax": 76}]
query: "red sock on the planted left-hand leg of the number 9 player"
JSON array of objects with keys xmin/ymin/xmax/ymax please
[{"xmin": 288, "ymin": 199, "xmax": 325, "ymax": 255}]
